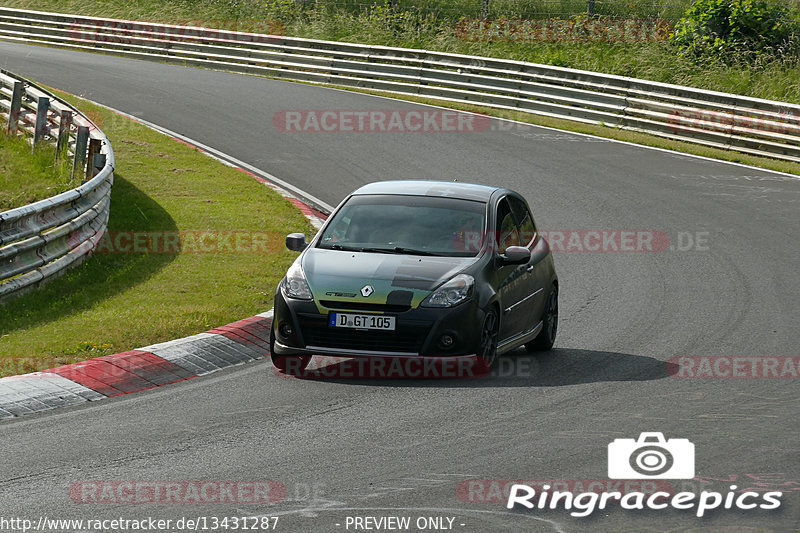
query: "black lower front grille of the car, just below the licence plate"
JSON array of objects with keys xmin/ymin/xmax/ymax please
[{"xmin": 298, "ymin": 316, "xmax": 430, "ymax": 353}]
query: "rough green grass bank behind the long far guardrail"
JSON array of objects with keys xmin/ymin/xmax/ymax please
[{"xmin": 0, "ymin": 0, "xmax": 800, "ymax": 103}]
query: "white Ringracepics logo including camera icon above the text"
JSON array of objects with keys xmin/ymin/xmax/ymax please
[{"xmin": 506, "ymin": 433, "xmax": 783, "ymax": 518}]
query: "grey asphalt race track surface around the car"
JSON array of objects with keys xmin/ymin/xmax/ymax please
[{"xmin": 0, "ymin": 43, "xmax": 800, "ymax": 532}]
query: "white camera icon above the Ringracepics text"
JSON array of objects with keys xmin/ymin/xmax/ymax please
[{"xmin": 608, "ymin": 433, "xmax": 694, "ymax": 479}]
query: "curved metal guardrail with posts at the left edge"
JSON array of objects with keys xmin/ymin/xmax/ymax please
[{"xmin": 0, "ymin": 70, "xmax": 114, "ymax": 300}]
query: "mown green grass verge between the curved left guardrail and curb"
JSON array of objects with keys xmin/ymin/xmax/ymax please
[{"xmin": 0, "ymin": 89, "xmax": 313, "ymax": 375}]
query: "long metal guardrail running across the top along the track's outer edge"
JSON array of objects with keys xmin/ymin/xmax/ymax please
[{"xmin": 0, "ymin": 8, "xmax": 800, "ymax": 162}]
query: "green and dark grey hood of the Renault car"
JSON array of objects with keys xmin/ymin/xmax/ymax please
[{"xmin": 302, "ymin": 248, "xmax": 477, "ymax": 307}]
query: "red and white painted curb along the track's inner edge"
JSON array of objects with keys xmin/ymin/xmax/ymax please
[{"xmin": 0, "ymin": 97, "xmax": 333, "ymax": 419}]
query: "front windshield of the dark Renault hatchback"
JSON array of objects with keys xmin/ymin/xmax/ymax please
[{"xmin": 317, "ymin": 195, "xmax": 486, "ymax": 257}]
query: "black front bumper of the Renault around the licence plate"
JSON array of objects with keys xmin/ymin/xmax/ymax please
[{"xmin": 272, "ymin": 290, "xmax": 483, "ymax": 358}]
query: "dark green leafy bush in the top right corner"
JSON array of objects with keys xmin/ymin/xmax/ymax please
[{"xmin": 672, "ymin": 0, "xmax": 800, "ymax": 63}]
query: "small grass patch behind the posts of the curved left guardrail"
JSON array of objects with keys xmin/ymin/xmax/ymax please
[{"xmin": 0, "ymin": 132, "xmax": 74, "ymax": 211}]
